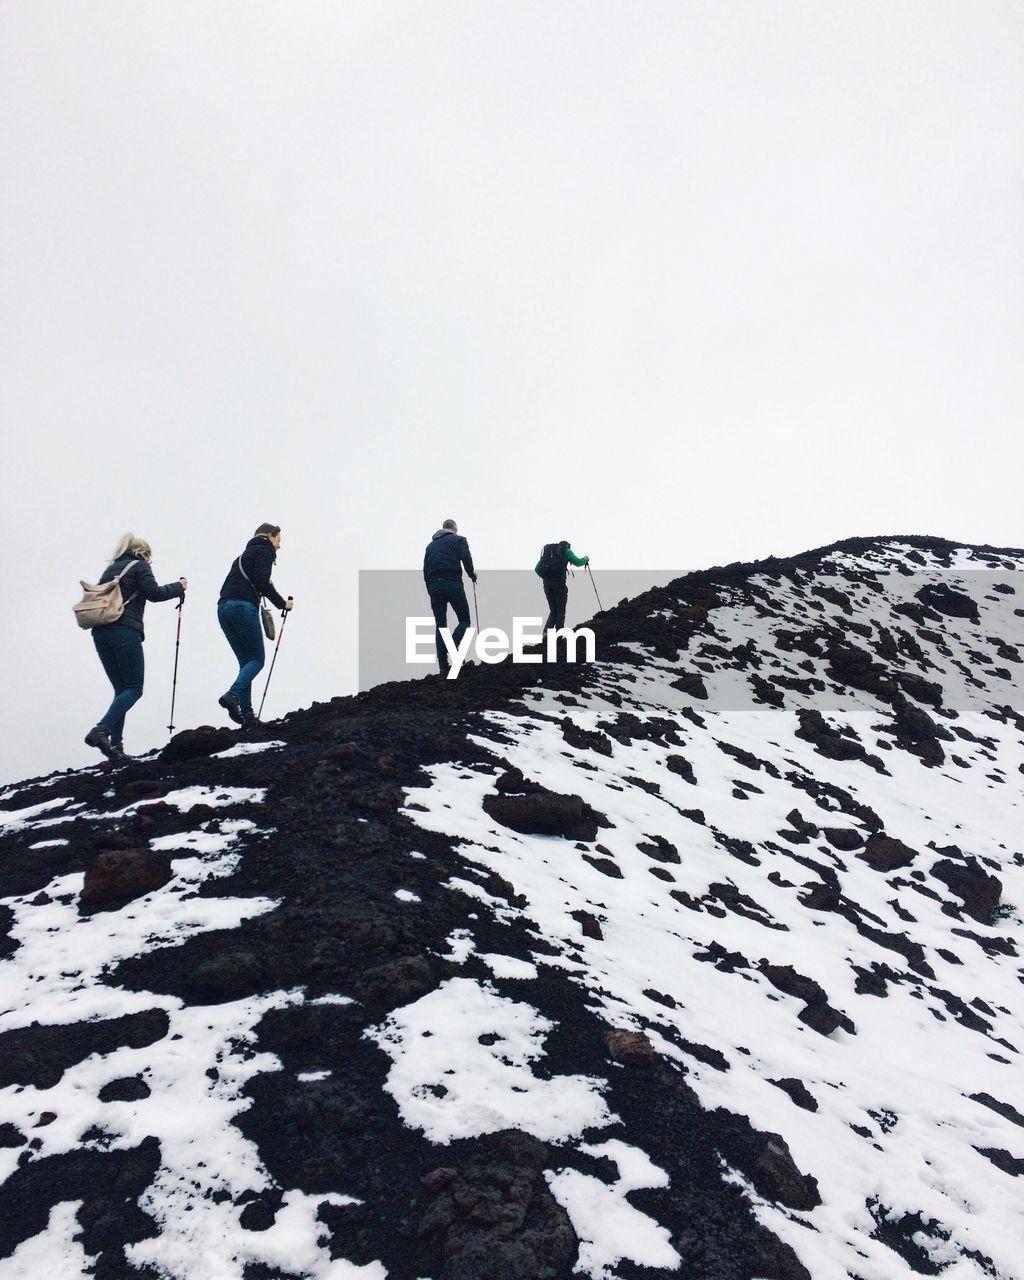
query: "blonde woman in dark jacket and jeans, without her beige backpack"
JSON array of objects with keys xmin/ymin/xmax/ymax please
[{"xmin": 86, "ymin": 534, "xmax": 188, "ymax": 760}]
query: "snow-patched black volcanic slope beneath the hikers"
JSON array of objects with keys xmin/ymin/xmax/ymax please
[{"xmin": 0, "ymin": 536, "xmax": 1024, "ymax": 1280}]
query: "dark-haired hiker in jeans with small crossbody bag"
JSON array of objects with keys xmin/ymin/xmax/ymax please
[{"xmin": 216, "ymin": 525, "xmax": 292, "ymax": 728}]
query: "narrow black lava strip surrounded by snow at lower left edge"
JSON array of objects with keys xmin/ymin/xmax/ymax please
[{"xmin": 0, "ymin": 1009, "xmax": 169, "ymax": 1089}]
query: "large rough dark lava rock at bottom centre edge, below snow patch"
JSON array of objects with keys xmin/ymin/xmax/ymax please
[{"xmin": 419, "ymin": 1132, "xmax": 579, "ymax": 1280}]
